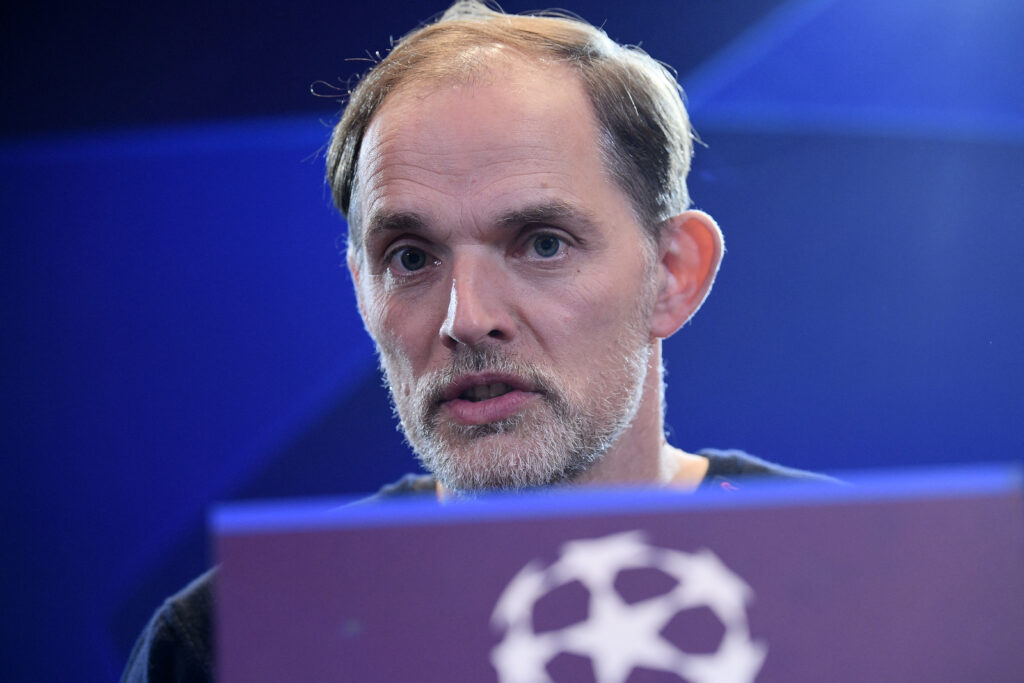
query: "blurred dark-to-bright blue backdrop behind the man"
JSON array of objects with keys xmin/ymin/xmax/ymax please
[{"xmin": 0, "ymin": 0, "xmax": 1024, "ymax": 680}]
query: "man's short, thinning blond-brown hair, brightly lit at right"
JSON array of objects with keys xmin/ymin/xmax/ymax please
[{"xmin": 327, "ymin": 0, "xmax": 694, "ymax": 249}]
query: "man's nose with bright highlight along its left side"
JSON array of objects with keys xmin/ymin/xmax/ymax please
[{"xmin": 440, "ymin": 250, "xmax": 514, "ymax": 349}]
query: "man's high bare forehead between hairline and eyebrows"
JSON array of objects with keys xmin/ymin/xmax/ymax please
[{"xmin": 353, "ymin": 59, "xmax": 629, "ymax": 240}]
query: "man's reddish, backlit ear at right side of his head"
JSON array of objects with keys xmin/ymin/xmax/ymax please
[{"xmin": 651, "ymin": 211, "xmax": 725, "ymax": 339}]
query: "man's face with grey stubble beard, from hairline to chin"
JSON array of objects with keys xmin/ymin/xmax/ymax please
[{"xmin": 349, "ymin": 62, "xmax": 656, "ymax": 490}]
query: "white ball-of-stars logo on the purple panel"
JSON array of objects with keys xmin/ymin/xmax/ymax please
[{"xmin": 490, "ymin": 531, "xmax": 767, "ymax": 683}]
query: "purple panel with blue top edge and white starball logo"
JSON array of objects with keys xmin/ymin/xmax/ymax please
[{"xmin": 212, "ymin": 468, "xmax": 1024, "ymax": 683}]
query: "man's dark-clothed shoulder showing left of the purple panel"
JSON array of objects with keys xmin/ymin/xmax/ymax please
[{"xmin": 121, "ymin": 569, "xmax": 216, "ymax": 683}]
